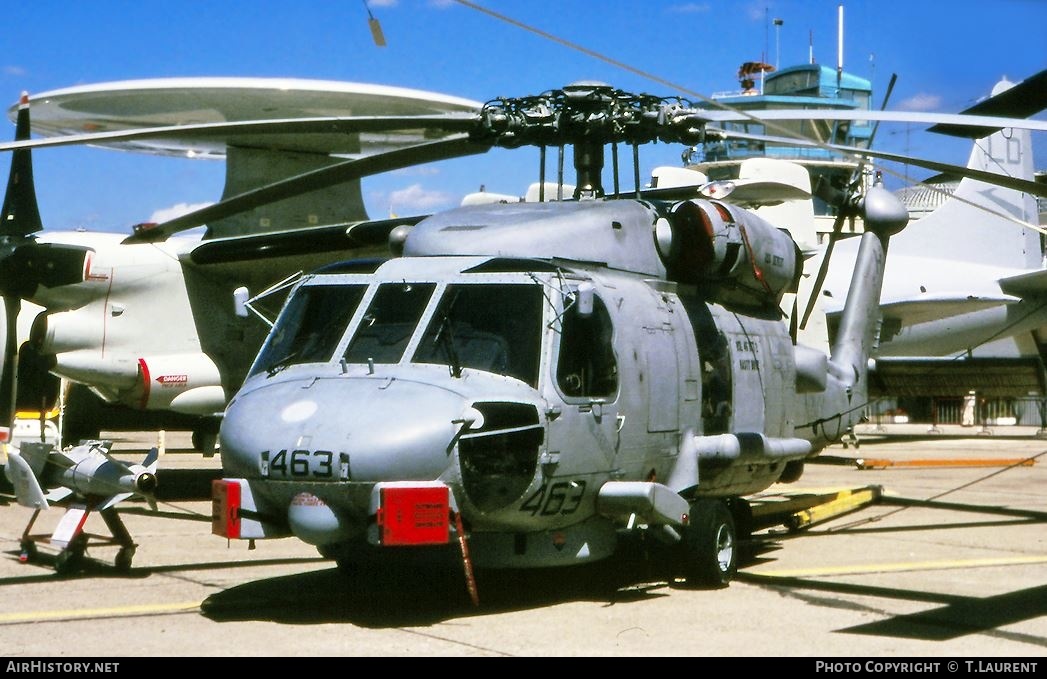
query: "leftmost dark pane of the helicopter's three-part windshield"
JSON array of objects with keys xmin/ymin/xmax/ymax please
[{"xmin": 251, "ymin": 285, "xmax": 367, "ymax": 375}]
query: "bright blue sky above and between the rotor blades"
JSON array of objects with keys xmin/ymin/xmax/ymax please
[{"xmin": 0, "ymin": 0, "xmax": 1047, "ymax": 231}]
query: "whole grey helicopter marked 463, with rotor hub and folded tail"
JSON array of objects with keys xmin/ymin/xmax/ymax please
[{"xmin": 214, "ymin": 83, "xmax": 908, "ymax": 591}]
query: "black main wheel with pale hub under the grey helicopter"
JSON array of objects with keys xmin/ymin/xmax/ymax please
[{"xmin": 680, "ymin": 500, "xmax": 738, "ymax": 588}]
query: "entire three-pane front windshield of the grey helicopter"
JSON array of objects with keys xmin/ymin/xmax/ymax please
[{"xmin": 251, "ymin": 278, "xmax": 545, "ymax": 387}]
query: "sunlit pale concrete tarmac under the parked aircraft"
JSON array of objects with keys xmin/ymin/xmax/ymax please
[{"xmin": 0, "ymin": 428, "xmax": 1047, "ymax": 657}]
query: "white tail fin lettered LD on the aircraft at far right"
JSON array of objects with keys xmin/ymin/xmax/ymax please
[{"xmin": 891, "ymin": 81, "xmax": 1042, "ymax": 269}]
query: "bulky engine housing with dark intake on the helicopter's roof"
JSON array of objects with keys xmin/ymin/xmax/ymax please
[{"xmin": 655, "ymin": 200, "xmax": 802, "ymax": 307}]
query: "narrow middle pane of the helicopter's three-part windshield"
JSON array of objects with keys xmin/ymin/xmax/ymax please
[{"xmin": 346, "ymin": 282, "xmax": 437, "ymax": 363}]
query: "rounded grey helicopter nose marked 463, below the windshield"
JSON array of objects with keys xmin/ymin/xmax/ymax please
[{"xmin": 220, "ymin": 377, "xmax": 469, "ymax": 482}]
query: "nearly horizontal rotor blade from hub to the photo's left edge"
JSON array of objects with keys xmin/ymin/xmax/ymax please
[{"xmin": 0, "ymin": 113, "xmax": 477, "ymax": 151}]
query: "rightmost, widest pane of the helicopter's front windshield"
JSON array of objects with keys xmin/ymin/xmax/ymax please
[{"xmin": 413, "ymin": 284, "xmax": 543, "ymax": 386}]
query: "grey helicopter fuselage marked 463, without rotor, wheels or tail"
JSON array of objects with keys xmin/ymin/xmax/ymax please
[{"xmin": 216, "ymin": 193, "xmax": 875, "ymax": 567}]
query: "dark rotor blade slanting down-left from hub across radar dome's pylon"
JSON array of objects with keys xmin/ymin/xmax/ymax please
[{"xmin": 124, "ymin": 135, "xmax": 491, "ymax": 244}]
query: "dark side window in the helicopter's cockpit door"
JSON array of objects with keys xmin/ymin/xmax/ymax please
[{"xmin": 556, "ymin": 297, "xmax": 618, "ymax": 398}]
